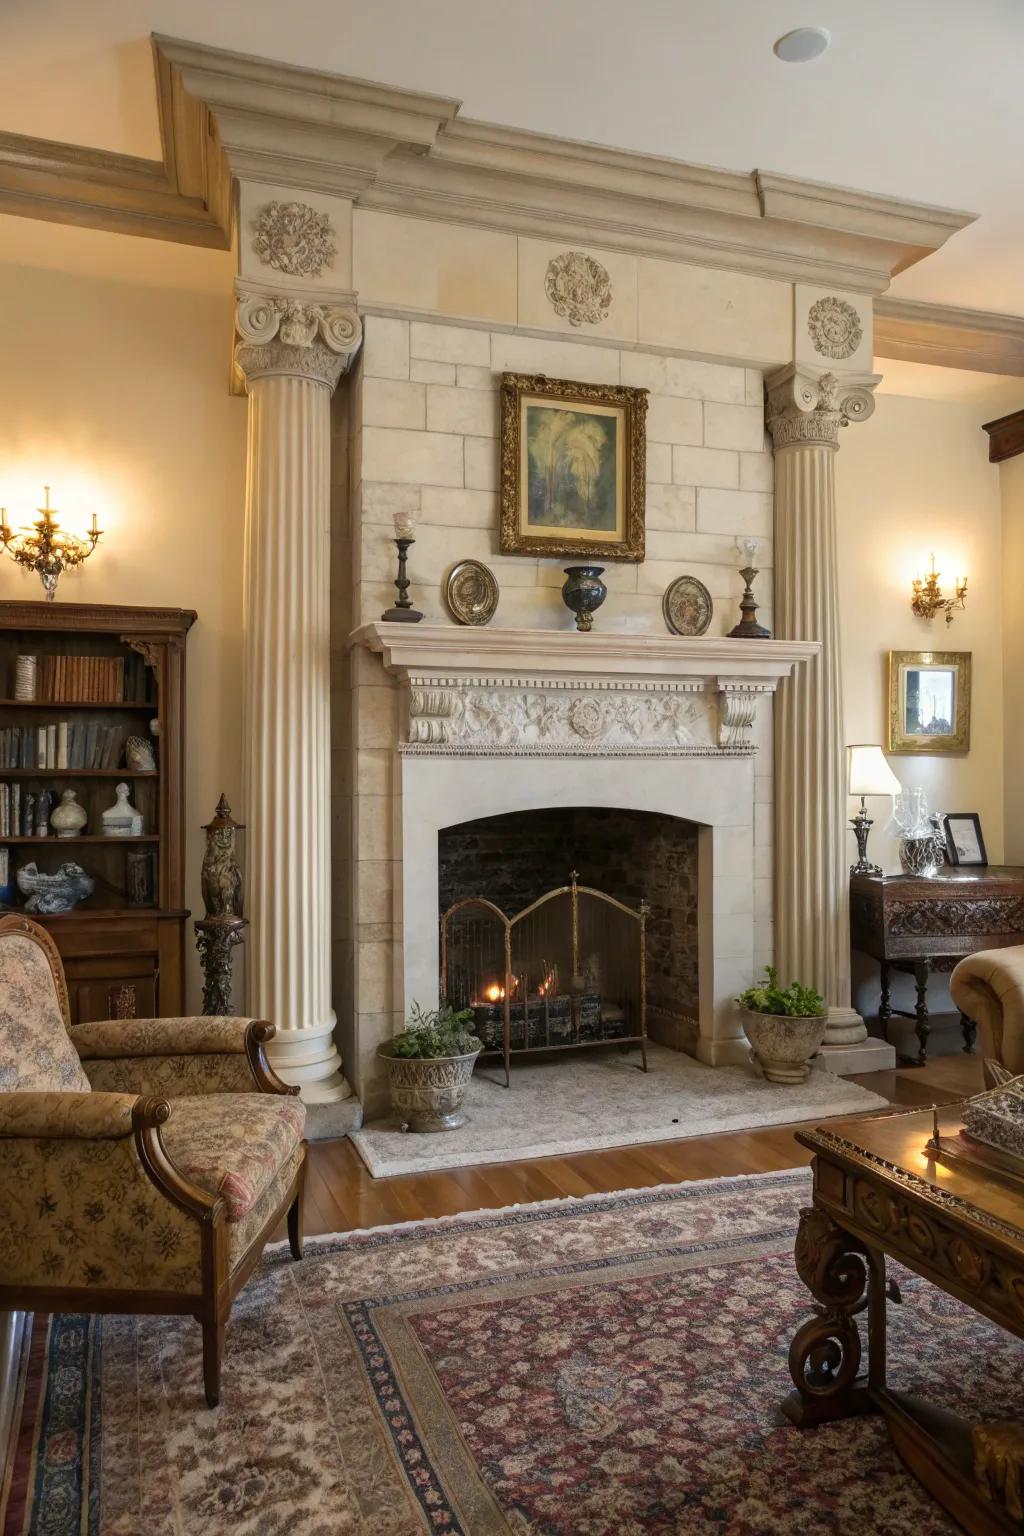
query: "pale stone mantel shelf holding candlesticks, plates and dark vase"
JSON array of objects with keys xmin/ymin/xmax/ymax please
[{"xmin": 350, "ymin": 624, "xmax": 821, "ymax": 691}]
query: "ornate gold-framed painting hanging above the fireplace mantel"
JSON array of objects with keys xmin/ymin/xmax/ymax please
[{"xmin": 500, "ymin": 373, "xmax": 648, "ymax": 561}]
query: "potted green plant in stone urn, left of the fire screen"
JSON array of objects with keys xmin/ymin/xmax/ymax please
[{"xmin": 378, "ymin": 1003, "xmax": 484, "ymax": 1130}]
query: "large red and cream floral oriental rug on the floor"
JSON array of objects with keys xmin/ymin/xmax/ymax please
[{"xmin": 0, "ymin": 1170, "xmax": 1024, "ymax": 1536}]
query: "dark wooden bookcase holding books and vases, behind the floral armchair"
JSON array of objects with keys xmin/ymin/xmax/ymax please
[{"xmin": 0, "ymin": 602, "xmax": 195, "ymax": 1023}]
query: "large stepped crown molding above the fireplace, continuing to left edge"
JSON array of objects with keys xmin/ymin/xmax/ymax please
[{"xmin": 0, "ymin": 35, "xmax": 973, "ymax": 293}]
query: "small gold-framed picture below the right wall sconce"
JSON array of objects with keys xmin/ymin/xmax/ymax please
[{"xmin": 889, "ymin": 651, "xmax": 970, "ymax": 757}]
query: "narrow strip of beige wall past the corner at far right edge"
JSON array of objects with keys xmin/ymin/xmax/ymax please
[{"xmin": 999, "ymin": 453, "xmax": 1024, "ymax": 865}]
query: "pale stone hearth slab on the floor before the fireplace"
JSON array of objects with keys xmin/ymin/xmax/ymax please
[{"xmin": 352, "ymin": 1044, "xmax": 887, "ymax": 1178}]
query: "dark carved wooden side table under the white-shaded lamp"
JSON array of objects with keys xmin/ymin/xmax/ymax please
[{"xmin": 851, "ymin": 865, "xmax": 1024, "ymax": 1066}]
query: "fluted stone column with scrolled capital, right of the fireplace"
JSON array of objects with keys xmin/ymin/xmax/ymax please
[{"xmin": 765, "ymin": 364, "xmax": 878, "ymax": 1046}]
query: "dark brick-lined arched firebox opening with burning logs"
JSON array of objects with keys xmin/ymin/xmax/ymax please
[{"xmin": 438, "ymin": 806, "xmax": 699, "ymax": 1069}]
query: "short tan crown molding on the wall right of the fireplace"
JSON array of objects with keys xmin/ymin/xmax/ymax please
[{"xmin": 875, "ymin": 296, "xmax": 1024, "ymax": 376}]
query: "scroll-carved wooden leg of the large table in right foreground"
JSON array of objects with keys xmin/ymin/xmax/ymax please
[{"xmin": 781, "ymin": 1206, "xmax": 886, "ymax": 1428}]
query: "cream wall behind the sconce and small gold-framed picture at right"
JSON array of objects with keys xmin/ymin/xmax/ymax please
[{"xmin": 837, "ymin": 384, "xmax": 1003, "ymax": 871}]
